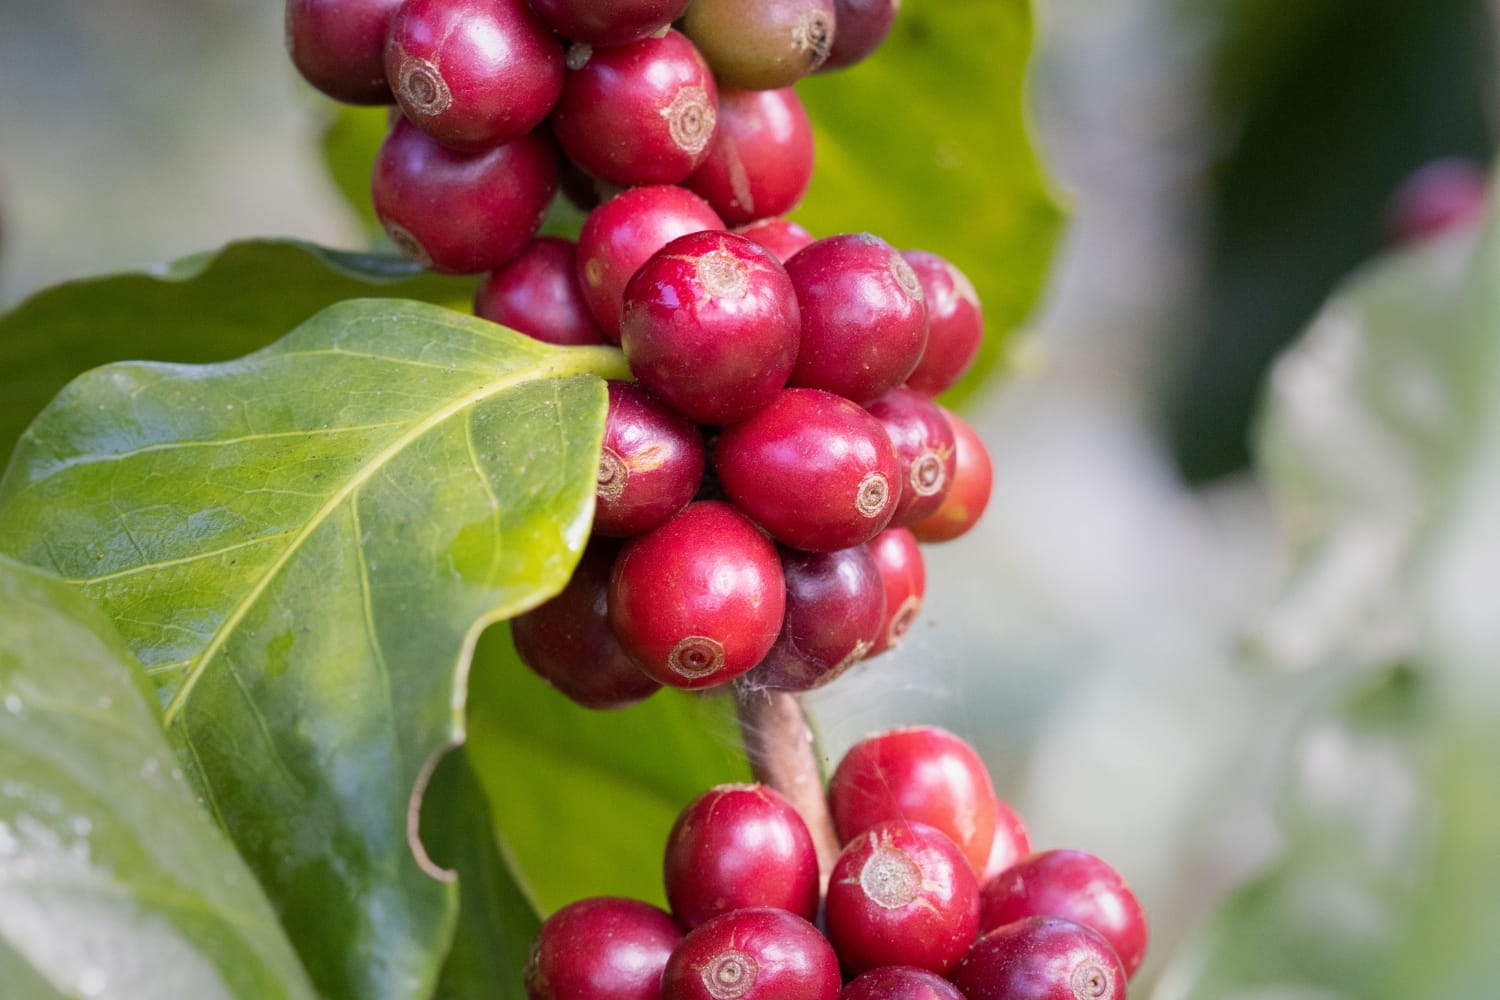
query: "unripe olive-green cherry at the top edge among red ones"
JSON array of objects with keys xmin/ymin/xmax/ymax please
[{"xmin": 683, "ymin": 0, "xmax": 834, "ymax": 90}]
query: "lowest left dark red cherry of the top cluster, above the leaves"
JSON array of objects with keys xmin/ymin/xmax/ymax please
[{"xmin": 371, "ymin": 118, "xmax": 558, "ymax": 274}]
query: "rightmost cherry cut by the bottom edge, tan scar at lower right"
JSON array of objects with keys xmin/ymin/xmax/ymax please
[{"xmin": 948, "ymin": 918, "xmax": 1127, "ymax": 1000}]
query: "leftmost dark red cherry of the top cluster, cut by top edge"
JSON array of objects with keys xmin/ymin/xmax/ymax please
[{"xmin": 287, "ymin": 0, "xmax": 401, "ymax": 105}]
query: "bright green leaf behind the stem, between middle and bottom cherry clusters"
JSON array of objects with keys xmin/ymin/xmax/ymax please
[{"xmin": 468, "ymin": 628, "xmax": 750, "ymax": 912}]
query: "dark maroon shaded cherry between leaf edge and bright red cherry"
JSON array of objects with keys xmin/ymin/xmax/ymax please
[{"xmin": 510, "ymin": 538, "xmax": 662, "ymax": 709}]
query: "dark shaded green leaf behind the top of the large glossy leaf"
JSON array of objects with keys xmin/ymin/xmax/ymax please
[{"xmin": 0, "ymin": 240, "xmax": 473, "ymax": 463}]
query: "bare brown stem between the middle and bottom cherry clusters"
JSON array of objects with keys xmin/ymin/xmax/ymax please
[{"xmin": 735, "ymin": 685, "xmax": 839, "ymax": 888}]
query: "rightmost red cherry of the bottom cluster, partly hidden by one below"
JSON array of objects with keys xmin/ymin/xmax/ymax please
[{"xmin": 981, "ymin": 850, "xmax": 1148, "ymax": 978}]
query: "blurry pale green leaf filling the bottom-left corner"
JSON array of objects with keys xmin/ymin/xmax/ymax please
[{"xmin": 0, "ymin": 558, "xmax": 315, "ymax": 1000}]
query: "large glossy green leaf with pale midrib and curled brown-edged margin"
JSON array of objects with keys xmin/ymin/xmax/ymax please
[{"xmin": 0, "ymin": 300, "xmax": 624, "ymax": 1000}]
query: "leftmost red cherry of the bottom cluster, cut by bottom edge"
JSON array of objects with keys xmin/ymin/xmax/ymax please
[{"xmin": 525, "ymin": 897, "xmax": 683, "ymax": 1000}]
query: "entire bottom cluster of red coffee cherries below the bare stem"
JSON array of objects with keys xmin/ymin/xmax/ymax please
[{"xmin": 525, "ymin": 727, "xmax": 1148, "ymax": 1000}]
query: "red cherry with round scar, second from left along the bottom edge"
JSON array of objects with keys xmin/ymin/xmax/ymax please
[{"xmin": 662, "ymin": 907, "xmax": 840, "ymax": 1000}]
